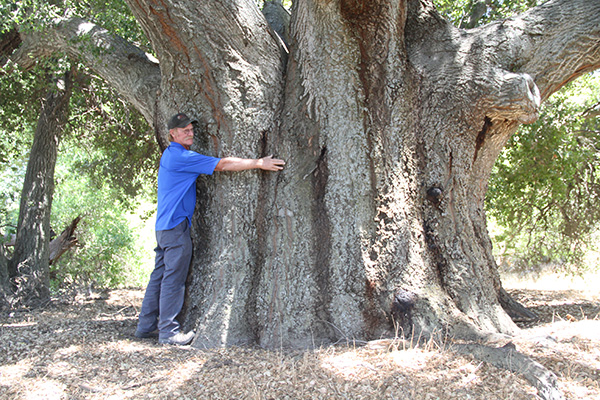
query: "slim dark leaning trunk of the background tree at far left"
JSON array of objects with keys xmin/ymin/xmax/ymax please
[{"xmin": 9, "ymin": 69, "xmax": 71, "ymax": 302}]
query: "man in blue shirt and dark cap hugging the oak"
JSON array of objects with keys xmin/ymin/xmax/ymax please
[{"xmin": 135, "ymin": 113, "xmax": 285, "ymax": 346}]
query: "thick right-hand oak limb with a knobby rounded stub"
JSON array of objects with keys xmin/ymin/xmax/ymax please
[{"xmin": 406, "ymin": 0, "xmax": 600, "ymax": 127}]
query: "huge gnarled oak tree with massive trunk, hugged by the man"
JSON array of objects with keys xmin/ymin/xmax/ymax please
[{"xmin": 5, "ymin": 0, "xmax": 600, "ymax": 347}]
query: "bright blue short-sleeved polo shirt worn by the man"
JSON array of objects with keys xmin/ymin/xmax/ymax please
[{"xmin": 156, "ymin": 143, "xmax": 220, "ymax": 231}]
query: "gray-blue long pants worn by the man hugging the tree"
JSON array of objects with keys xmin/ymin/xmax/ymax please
[{"xmin": 137, "ymin": 220, "xmax": 192, "ymax": 339}]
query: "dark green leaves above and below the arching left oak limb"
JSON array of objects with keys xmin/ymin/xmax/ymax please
[{"xmin": 0, "ymin": 0, "xmax": 158, "ymax": 206}]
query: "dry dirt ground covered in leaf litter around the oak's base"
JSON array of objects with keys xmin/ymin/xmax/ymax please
[{"xmin": 0, "ymin": 282, "xmax": 600, "ymax": 400}]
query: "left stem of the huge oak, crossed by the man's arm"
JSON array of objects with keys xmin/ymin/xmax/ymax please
[{"xmin": 123, "ymin": 0, "xmax": 284, "ymax": 346}]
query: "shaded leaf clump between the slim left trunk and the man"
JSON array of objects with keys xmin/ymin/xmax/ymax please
[{"xmin": 64, "ymin": 74, "xmax": 159, "ymax": 204}]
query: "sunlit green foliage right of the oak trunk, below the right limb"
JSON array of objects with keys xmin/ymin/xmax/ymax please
[{"xmin": 487, "ymin": 75, "xmax": 600, "ymax": 272}]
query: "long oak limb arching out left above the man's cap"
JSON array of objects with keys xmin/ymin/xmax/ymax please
[{"xmin": 11, "ymin": 18, "xmax": 161, "ymax": 125}]
